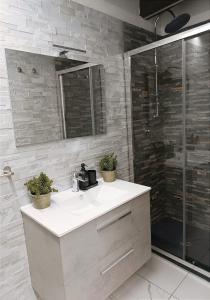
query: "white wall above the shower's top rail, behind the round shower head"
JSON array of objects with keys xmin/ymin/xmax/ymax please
[{"xmin": 158, "ymin": 0, "xmax": 210, "ymax": 34}]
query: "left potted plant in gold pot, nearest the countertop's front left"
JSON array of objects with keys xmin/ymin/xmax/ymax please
[{"xmin": 25, "ymin": 172, "xmax": 58, "ymax": 209}]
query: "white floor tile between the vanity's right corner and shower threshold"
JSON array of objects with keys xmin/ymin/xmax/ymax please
[{"xmin": 138, "ymin": 254, "xmax": 187, "ymax": 294}]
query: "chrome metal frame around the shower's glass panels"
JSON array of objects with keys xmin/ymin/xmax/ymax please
[{"xmin": 124, "ymin": 20, "xmax": 210, "ymax": 278}]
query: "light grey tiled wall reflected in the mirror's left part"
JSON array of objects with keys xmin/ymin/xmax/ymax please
[{"xmin": 6, "ymin": 49, "xmax": 62, "ymax": 147}]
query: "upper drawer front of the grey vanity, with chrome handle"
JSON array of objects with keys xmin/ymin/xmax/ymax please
[{"xmin": 97, "ymin": 195, "xmax": 150, "ymax": 260}]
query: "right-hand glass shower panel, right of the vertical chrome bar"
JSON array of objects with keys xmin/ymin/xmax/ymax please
[{"xmin": 185, "ymin": 32, "xmax": 210, "ymax": 271}]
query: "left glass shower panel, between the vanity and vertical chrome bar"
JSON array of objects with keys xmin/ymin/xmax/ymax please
[{"xmin": 131, "ymin": 41, "xmax": 184, "ymax": 258}]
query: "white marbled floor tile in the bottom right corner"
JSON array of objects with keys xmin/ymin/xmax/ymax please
[{"xmin": 173, "ymin": 274, "xmax": 210, "ymax": 300}]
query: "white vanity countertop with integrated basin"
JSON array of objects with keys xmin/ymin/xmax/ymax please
[{"xmin": 21, "ymin": 179, "xmax": 151, "ymax": 237}]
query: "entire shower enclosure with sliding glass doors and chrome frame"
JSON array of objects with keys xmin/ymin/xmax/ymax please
[{"xmin": 125, "ymin": 23, "xmax": 210, "ymax": 278}]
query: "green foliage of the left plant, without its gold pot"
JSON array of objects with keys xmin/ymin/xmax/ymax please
[{"xmin": 25, "ymin": 172, "xmax": 58, "ymax": 197}]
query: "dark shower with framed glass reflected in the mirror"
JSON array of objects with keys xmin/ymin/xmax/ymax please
[{"xmin": 59, "ymin": 64, "xmax": 105, "ymax": 138}]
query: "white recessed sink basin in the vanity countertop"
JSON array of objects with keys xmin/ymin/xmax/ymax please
[{"xmin": 52, "ymin": 184, "xmax": 127, "ymax": 215}]
